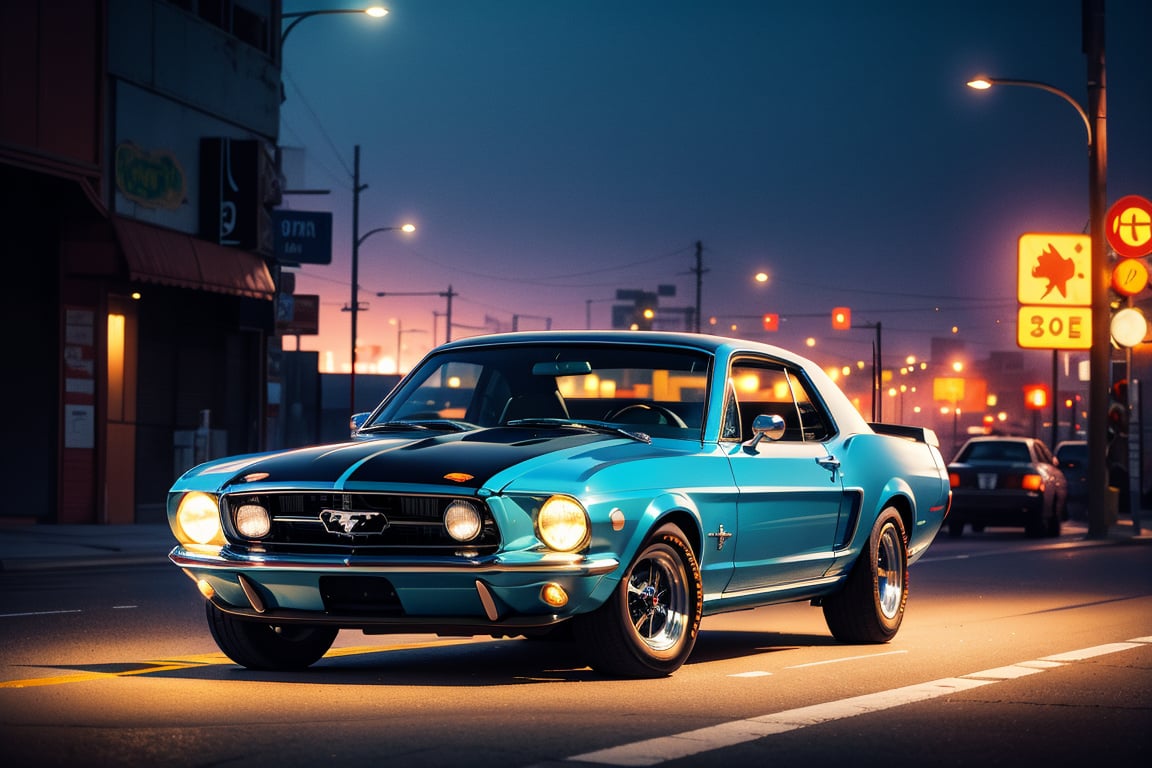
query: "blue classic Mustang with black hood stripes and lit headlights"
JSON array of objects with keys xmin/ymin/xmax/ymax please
[{"xmin": 168, "ymin": 332, "xmax": 950, "ymax": 677}]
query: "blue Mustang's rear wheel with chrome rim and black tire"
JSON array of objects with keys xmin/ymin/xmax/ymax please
[{"xmin": 823, "ymin": 507, "xmax": 908, "ymax": 642}]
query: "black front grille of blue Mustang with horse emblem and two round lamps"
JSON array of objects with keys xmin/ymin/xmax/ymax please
[{"xmin": 223, "ymin": 493, "xmax": 500, "ymax": 556}]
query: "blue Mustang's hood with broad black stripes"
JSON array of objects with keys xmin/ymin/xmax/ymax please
[{"xmin": 180, "ymin": 427, "xmax": 652, "ymax": 489}]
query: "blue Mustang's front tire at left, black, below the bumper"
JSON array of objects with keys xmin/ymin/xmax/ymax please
[{"xmin": 206, "ymin": 602, "xmax": 339, "ymax": 670}]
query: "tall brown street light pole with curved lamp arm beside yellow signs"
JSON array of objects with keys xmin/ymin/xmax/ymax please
[{"xmin": 968, "ymin": 0, "xmax": 1112, "ymax": 539}]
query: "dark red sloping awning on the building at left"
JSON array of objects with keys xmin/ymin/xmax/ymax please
[{"xmin": 112, "ymin": 216, "xmax": 275, "ymax": 301}]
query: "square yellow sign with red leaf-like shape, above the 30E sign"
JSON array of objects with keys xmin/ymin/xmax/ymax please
[{"xmin": 1016, "ymin": 233, "xmax": 1092, "ymax": 308}]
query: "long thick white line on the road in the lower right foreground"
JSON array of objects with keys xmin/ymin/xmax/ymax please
[{"xmin": 552, "ymin": 636, "xmax": 1152, "ymax": 766}]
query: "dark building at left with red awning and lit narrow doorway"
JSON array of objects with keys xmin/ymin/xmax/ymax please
[{"xmin": 0, "ymin": 0, "xmax": 280, "ymax": 523}]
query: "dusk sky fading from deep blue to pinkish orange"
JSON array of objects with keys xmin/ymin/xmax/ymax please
[{"xmin": 280, "ymin": 0, "xmax": 1152, "ymax": 372}]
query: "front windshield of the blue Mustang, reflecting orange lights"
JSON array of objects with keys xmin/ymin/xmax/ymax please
[{"xmin": 363, "ymin": 343, "xmax": 711, "ymax": 438}]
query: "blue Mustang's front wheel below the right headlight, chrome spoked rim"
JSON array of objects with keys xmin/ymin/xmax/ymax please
[{"xmin": 573, "ymin": 525, "xmax": 704, "ymax": 677}]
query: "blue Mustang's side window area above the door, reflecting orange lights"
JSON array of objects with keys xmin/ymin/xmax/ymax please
[{"xmin": 726, "ymin": 359, "xmax": 832, "ymax": 441}]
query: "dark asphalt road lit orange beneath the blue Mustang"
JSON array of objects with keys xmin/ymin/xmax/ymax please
[{"xmin": 0, "ymin": 530, "xmax": 1152, "ymax": 768}]
